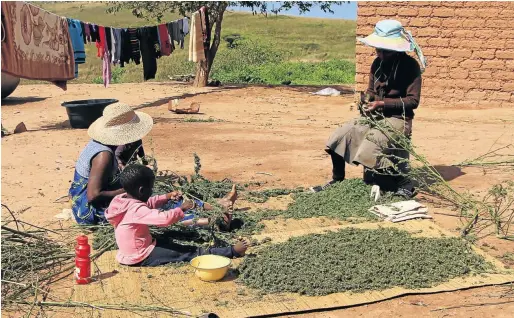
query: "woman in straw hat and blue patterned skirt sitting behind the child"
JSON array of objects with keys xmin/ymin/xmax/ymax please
[{"xmin": 69, "ymin": 103, "xmax": 153, "ymax": 225}]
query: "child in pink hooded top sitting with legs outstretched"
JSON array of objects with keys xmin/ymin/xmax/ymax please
[{"xmin": 105, "ymin": 165, "xmax": 248, "ymax": 266}]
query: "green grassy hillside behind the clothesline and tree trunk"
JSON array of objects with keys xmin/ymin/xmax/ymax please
[{"xmin": 24, "ymin": 2, "xmax": 355, "ymax": 85}]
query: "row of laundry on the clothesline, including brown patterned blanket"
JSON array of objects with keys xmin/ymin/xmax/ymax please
[{"xmin": 2, "ymin": 1, "xmax": 206, "ymax": 90}]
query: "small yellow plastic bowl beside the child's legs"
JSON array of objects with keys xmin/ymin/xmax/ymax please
[{"xmin": 191, "ymin": 255, "xmax": 232, "ymax": 282}]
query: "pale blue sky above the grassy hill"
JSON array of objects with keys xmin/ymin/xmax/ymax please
[{"xmin": 229, "ymin": 1, "xmax": 357, "ymax": 20}]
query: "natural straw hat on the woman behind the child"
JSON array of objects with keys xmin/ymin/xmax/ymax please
[{"xmin": 87, "ymin": 103, "xmax": 153, "ymax": 146}]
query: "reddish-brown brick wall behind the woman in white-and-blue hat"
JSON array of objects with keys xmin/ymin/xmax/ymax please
[{"xmin": 355, "ymin": 1, "xmax": 514, "ymax": 107}]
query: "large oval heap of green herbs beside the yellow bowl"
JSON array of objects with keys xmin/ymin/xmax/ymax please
[{"xmin": 239, "ymin": 228, "xmax": 491, "ymax": 295}]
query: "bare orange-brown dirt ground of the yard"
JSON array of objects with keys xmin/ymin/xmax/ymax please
[{"xmin": 1, "ymin": 83, "xmax": 514, "ymax": 317}]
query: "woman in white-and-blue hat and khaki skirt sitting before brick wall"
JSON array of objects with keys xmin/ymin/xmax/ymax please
[{"xmin": 311, "ymin": 20, "xmax": 426, "ymax": 198}]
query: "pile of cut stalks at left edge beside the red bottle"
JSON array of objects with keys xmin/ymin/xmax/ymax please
[{"xmin": 1, "ymin": 204, "xmax": 75, "ymax": 308}]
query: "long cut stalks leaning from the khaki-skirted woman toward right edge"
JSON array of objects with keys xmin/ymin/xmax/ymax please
[{"xmin": 354, "ymin": 105, "xmax": 514, "ymax": 239}]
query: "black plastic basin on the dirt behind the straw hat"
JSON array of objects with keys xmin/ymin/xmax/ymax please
[{"xmin": 61, "ymin": 99, "xmax": 118, "ymax": 128}]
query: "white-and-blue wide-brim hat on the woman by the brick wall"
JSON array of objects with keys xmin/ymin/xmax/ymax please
[{"xmin": 357, "ymin": 20, "xmax": 414, "ymax": 52}]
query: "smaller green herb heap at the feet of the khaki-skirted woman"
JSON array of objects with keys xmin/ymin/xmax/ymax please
[{"xmin": 282, "ymin": 179, "xmax": 395, "ymax": 220}]
